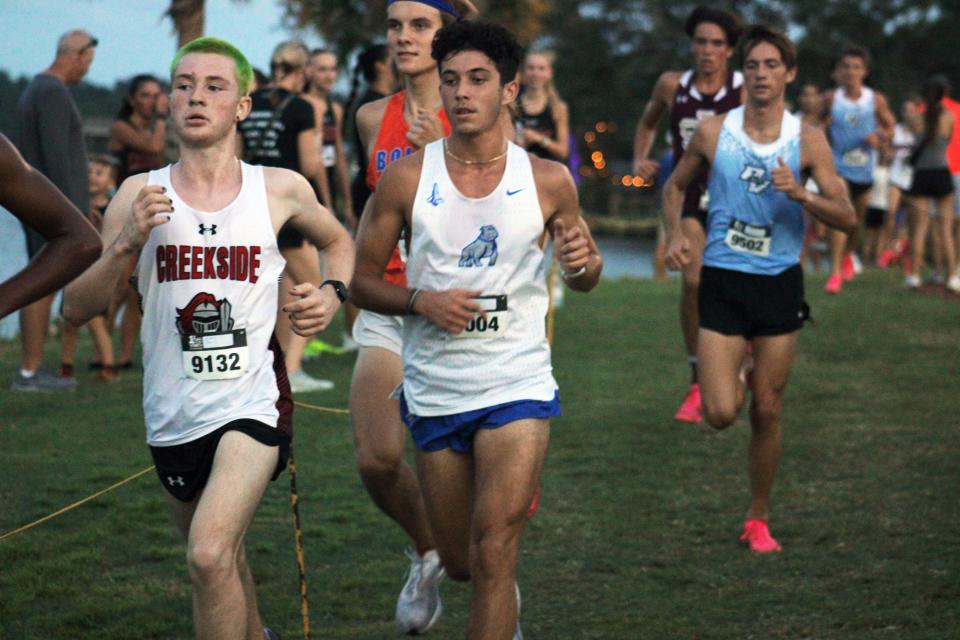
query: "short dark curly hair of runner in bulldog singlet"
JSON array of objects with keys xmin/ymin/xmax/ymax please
[{"xmin": 431, "ymin": 20, "xmax": 523, "ymax": 86}]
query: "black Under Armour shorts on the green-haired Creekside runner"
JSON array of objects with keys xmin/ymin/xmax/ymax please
[{"xmin": 150, "ymin": 418, "xmax": 290, "ymax": 502}]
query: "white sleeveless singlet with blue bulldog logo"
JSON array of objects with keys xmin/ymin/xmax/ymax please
[{"xmin": 403, "ymin": 140, "xmax": 557, "ymax": 416}]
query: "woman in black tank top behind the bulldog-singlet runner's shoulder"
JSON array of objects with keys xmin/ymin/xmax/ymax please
[{"xmin": 516, "ymin": 51, "xmax": 570, "ymax": 164}]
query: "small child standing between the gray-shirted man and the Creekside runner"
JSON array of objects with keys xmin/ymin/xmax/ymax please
[{"xmin": 60, "ymin": 156, "xmax": 117, "ymax": 382}]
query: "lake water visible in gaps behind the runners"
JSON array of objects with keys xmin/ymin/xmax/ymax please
[{"xmin": 0, "ymin": 207, "xmax": 653, "ymax": 339}]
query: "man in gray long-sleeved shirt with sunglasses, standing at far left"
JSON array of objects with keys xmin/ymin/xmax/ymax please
[{"xmin": 13, "ymin": 30, "xmax": 97, "ymax": 391}]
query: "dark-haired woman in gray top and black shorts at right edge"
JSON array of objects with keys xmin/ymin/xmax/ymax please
[{"xmin": 906, "ymin": 75, "xmax": 960, "ymax": 292}]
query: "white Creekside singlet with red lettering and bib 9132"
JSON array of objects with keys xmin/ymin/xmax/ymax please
[{"xmin": 136, "ymin": 163, "xmax": 292, "ymax": 446}]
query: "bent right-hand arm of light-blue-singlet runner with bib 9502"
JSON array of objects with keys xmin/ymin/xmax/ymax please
[{"xmin": 792, "ymin": 125, "xmax": 857, "ymax": 231}]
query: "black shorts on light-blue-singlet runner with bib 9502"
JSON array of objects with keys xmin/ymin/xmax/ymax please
[{"xmin": 699, "ymin": 265, "xmax": 810, "ymax": 340}]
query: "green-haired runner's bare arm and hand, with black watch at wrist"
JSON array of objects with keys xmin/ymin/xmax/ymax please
[{"xmin": 264, "ymin": 168, "xmax": 353, "ymax": 336}]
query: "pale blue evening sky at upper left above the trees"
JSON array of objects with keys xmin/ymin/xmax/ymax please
[{"xmin": 0, "ymin": 0, "xmax": 334, "ymax": 86}]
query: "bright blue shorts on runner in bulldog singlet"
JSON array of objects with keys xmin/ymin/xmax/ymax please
[{"xmin": 400, "ymin": 391, "xmax": 560, "ymax": 453}]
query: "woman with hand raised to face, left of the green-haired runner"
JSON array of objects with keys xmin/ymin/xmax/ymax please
[{"xmin": 108, "ymin": 74, "xmax": 168, "ymax": 370}]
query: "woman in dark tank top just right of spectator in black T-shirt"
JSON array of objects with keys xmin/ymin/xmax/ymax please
[{"xmin": 303, "ymin": 49, "xmax": 357, "ymax": 230}]
